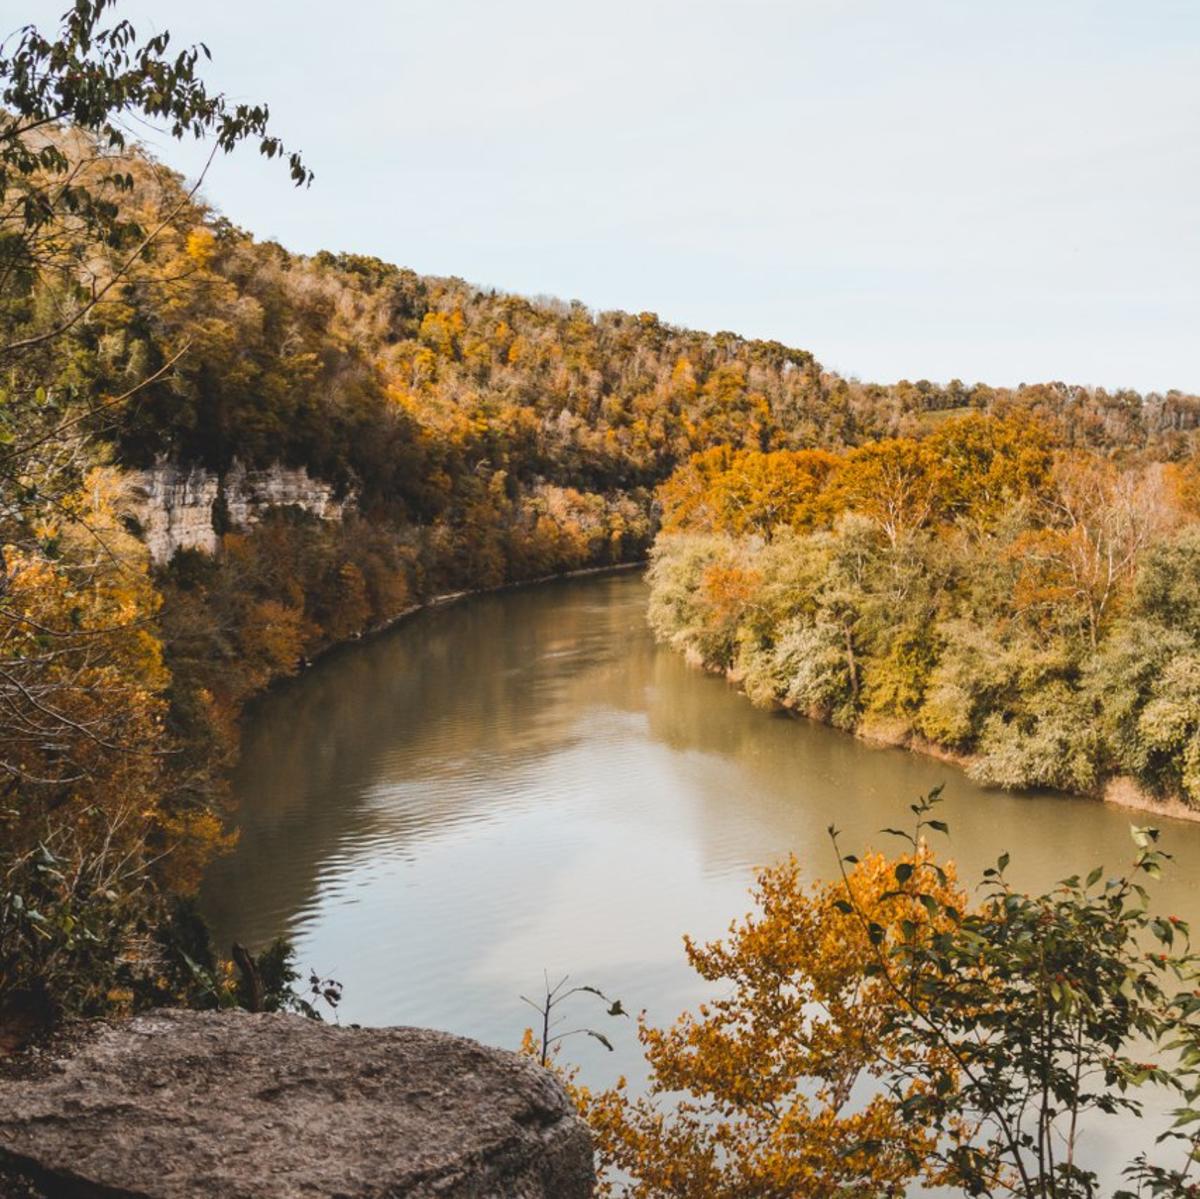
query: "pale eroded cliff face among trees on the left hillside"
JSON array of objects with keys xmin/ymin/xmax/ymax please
[{"xmin": 126, "ymin": 461, "xmax": 353, "ymax": 563}]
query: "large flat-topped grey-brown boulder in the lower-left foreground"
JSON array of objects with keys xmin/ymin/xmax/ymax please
[{"xmin": 0, "ymin": 1012, "xmax": 594, "ymax": 1199}]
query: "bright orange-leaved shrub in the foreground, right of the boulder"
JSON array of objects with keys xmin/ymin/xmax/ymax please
[{"xmin": 582, "ymin": 849, "xmax": 964, "ymax": 1199}]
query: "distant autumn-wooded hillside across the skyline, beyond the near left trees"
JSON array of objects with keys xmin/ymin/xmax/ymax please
[{"xmin": 28, "ymin": 145, "xmax": 1200, "ymax": 801}]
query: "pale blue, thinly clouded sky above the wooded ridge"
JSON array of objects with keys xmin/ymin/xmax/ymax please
[{"xmin": 14, "ymin": 0, "xmax": 1200, "ymax": 391}]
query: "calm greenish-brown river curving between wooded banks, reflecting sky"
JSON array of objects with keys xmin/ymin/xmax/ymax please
[{"xmin": 203, "ymin": 572, "xmax": 1200, "ymax": 1180}]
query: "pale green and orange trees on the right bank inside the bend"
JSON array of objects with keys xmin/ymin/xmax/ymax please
[{"xmin": 649, "ymin": 412, "xmax": 1200, "ymax": 803}]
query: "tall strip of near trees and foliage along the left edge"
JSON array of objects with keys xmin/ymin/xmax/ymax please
[{"xmin": 0, "ymin": 0, "xmax": 307, "ymax": 1021}]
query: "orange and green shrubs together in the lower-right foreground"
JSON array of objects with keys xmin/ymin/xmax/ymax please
[{"xmin": 585, "ymin": 792, "xmax": 1200, "ymax": 1199}]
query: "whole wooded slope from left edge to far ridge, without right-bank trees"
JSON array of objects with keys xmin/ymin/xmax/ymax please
[{"xmin": 7, "ymin": 134, "xmax": 1200, "ymax": 1011}]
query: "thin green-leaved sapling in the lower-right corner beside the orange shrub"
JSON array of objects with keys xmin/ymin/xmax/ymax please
[{"xmin": 830, "ymin": 795, "xmax": 1200, "ymax": 1199}]
